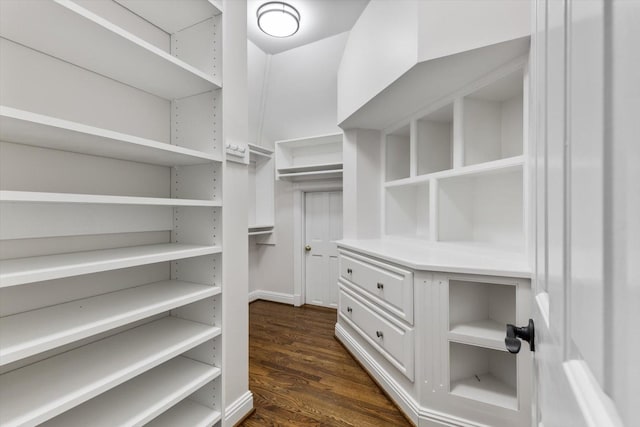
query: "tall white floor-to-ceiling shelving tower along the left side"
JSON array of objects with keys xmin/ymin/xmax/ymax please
[{"xmin": 0, "ymin": 0, "xmax": 235, "ymax": 427}]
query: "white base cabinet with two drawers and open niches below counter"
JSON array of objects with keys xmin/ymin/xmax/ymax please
[{"xmin": 336, "ymin": 246, "xmax": 532, "ymax": 426}]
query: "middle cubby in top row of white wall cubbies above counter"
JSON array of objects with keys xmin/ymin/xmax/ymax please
[{"xmin": 416, "ymin": 104, "xmax": 453, "ymax": 175}]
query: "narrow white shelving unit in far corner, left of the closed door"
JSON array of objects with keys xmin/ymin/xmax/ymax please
[{"xmin": 249, "ymin": 144, "xmax": 275, "ymax": 236}]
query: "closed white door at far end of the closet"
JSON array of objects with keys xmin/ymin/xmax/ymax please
[{"xmin": 304, "ymin": 191, "xmax": 342, "ymax": 308}]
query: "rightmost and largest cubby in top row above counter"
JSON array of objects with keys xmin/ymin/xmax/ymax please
[{"xmin": 462, "ymin": 69, "xmax": 523, "ymax": 166}]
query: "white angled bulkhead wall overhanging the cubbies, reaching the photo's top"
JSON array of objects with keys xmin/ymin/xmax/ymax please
[{"xmin": 338, "ymin": 0, "xmax": 530, "ymax": 127}]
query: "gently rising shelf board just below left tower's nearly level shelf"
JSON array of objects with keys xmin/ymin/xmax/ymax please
[{"xmin": 0, "ymin": 243, "xmax": 222, "ymax": 288}]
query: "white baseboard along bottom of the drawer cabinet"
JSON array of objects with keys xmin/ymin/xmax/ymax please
[{"xmin": 335, "ymin": 323, "xmax": 479, "ymax": 427}]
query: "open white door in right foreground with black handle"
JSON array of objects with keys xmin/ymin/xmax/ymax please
[{"xmin": 531, "ymin": 0, "xmax": 640, "ymax": 427}]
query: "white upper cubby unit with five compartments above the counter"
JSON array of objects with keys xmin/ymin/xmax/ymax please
[{"xmin": 382, "ymin": 61, "xmax": 527, "ymax": 257}]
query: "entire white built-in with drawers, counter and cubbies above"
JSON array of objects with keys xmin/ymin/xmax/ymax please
[{"xmin": 336, "ymin": 58, "xmax": 533, "ymax": 427}]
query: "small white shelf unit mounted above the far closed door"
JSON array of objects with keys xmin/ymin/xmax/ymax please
[{"xmin": 275, "ymin": 133, "xmax": 342, "ymax": 181}]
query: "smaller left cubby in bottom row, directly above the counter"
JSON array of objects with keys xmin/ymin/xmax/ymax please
[{"xmin": 385, "ymin": 182, "xmax": 430, "ymax": 239}]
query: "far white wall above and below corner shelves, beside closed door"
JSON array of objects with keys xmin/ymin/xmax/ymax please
[{"xmin": 249, "ymin": 33, "xmax": 348, "ymax": 296}]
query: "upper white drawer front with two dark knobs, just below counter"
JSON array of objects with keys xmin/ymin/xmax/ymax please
[{"xmin": 340, "ymin": 252, "xmax": 413, "ymax": 325}]
